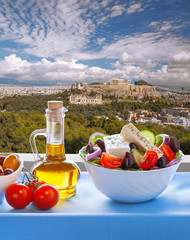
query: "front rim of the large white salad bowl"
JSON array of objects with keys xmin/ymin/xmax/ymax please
[{"xmin": 79, "ymin": 146, "xmax": 184, "ymax": 174}]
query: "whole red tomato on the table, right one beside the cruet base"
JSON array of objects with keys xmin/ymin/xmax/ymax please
[{"xmin": 32, "ymin": 184, "xmax": 59, "ymax": 210}]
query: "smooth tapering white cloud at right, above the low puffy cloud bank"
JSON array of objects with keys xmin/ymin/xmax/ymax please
[{"xmin": 93, "ymin": 32, "xmax": 189, "ymax": 64}]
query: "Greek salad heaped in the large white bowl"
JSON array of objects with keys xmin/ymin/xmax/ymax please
[{"xmin": 80, "ymin": 123, "xmax": 181, "ymax": 171}]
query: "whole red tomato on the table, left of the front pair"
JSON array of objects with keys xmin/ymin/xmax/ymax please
[{"xmin": 5, "ymin": 183, "xmax": 32, "ymax": 209}]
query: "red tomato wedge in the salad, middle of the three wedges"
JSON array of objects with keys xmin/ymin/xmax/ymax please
[{"xmin": 139, "ymin": 151, "xmax": 158, "ymax": 170}]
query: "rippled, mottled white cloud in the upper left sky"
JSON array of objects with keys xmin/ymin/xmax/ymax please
[{"xmin": 0, "ymin": 0, "xmax": 95, "ymax": 57}]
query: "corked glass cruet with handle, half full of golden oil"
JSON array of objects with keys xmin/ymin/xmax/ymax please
[{"xmin": 30, "ymin": 101, "xmax": 80, "ymax": 198}]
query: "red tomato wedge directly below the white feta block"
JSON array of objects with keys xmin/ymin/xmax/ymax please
[{"xmin": 100, "ymin": 153, "xmax": 123, "ymax": 168}]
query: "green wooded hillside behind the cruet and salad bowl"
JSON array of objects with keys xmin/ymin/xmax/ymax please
[{"xmin": 0, "ymin": 91, "xmax": 190, "ymax": 154}]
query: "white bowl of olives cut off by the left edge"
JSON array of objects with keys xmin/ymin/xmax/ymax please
[{"xmin": 0, "ymin": 153, "xmax": 23, "ymax": 203}]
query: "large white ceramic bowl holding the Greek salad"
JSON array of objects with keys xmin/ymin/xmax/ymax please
[{"xmin": 79, "ymin": 149, "xmax": 184, "ymax": 203}]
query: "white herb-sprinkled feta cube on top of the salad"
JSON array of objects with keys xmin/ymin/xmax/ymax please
[{"xmin": 104, "ymin": 134, "xmax": 130, "ymax": 158}]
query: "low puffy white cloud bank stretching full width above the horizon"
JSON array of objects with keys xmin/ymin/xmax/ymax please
[{"xmin": 0, "ymin": 49, "xmax": 190, "ymax": 87}]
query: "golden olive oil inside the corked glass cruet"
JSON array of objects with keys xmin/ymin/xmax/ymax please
[{"xmin": 32, "ymin": 144, "xmax": 79, "ymax": 198}]
